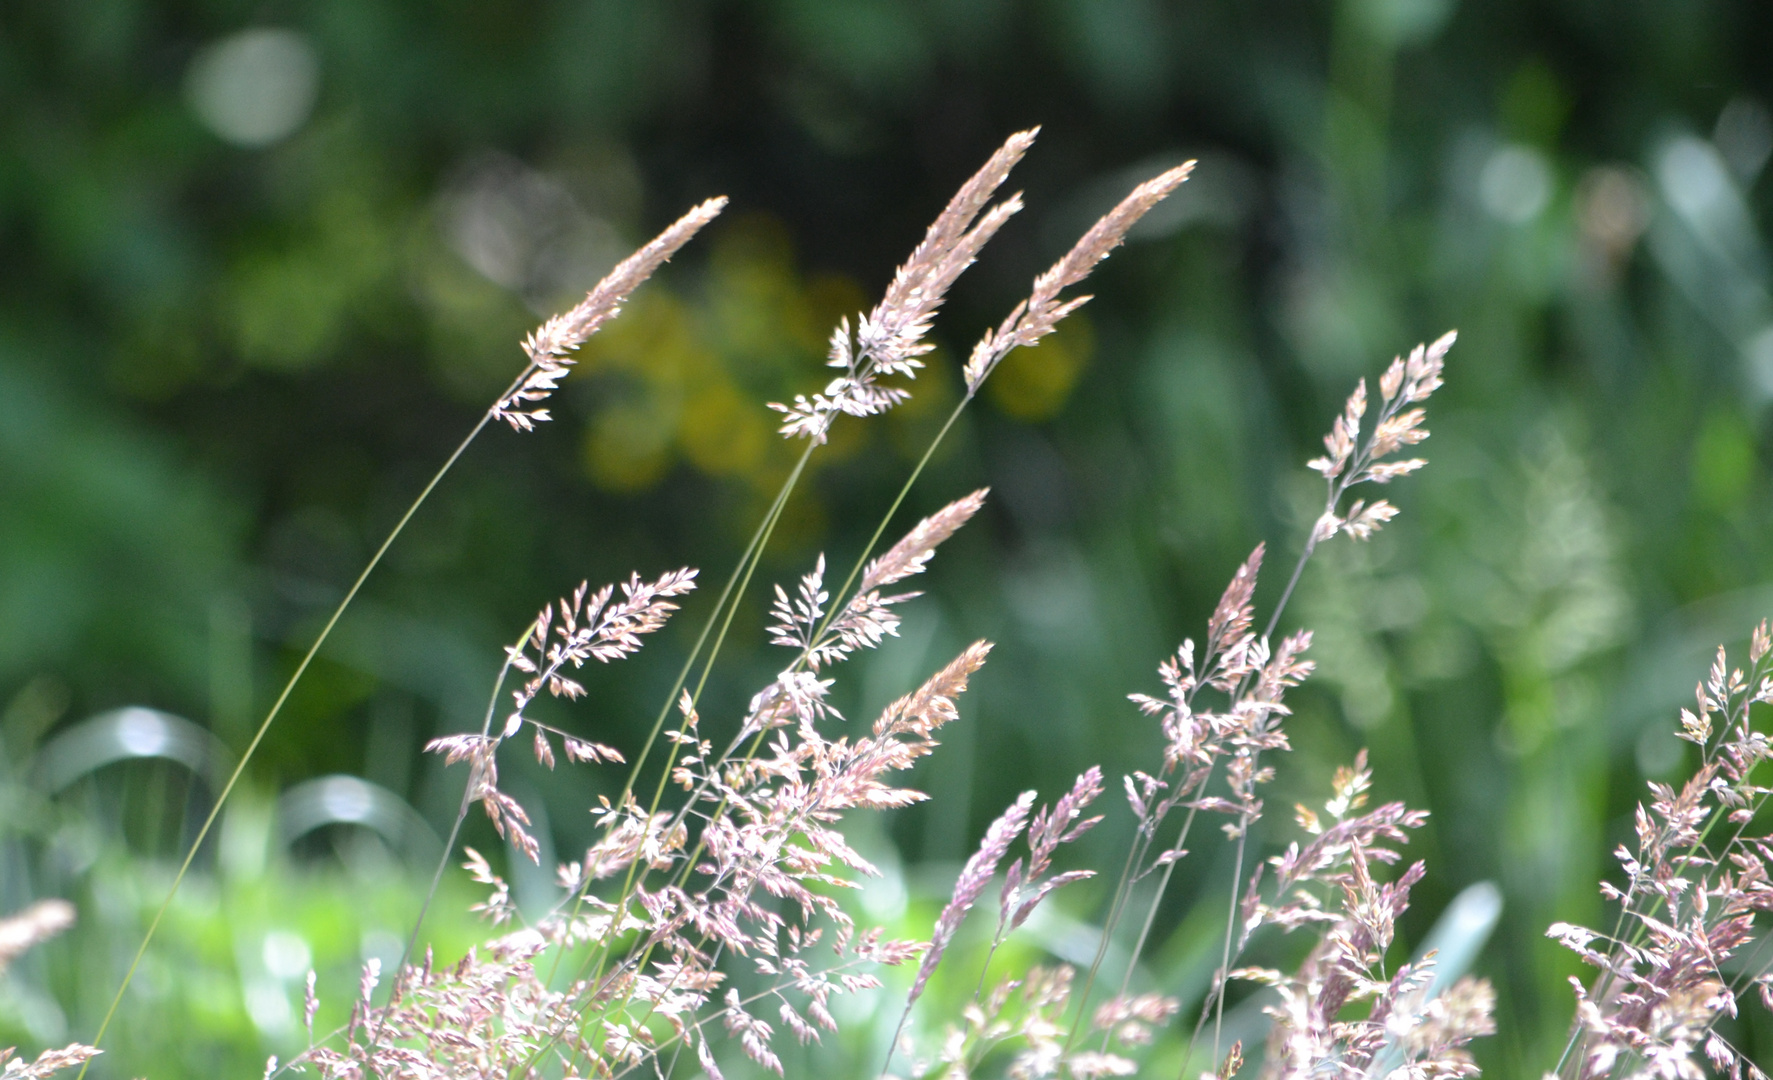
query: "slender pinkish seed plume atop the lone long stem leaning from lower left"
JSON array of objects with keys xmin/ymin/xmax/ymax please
[{"xmin": 493, "ymin": 195, "xmax": 727, "ymax": 431}]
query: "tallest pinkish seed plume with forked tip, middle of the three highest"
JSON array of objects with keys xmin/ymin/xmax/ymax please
[{"xmin": 769, "ymin": 129, "xmax": 1037, "ymax": 443}]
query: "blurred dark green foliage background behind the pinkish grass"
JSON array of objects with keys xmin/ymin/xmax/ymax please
[{"xmin": 10, "ymin": 0, "xmax": 1773, "ymax": 1076}]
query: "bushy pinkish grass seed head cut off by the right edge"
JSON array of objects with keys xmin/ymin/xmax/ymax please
[{"xmin": 1546, "ymin": 621, "xmax": 1773, "ymax": 1080}]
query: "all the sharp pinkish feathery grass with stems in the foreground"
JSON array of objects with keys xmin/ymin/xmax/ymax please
[{"xmin": 44, "ymin": 131, "xmax": 1773, "ymax": 1080}]
